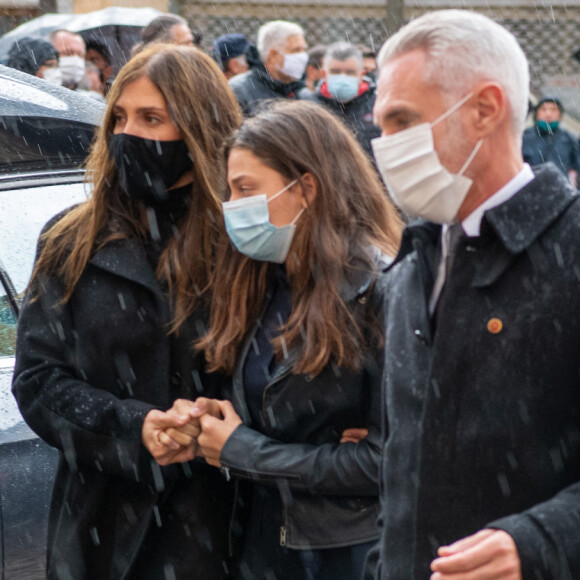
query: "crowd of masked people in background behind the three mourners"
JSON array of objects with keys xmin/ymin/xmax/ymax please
[{"xmin": 5, "ymin": 14, "xmax": 580, "ymax": 177}]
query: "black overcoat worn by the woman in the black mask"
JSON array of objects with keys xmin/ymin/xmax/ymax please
[{"xmin": 13, "ymin": 233, "xmax": 231, "ymax": 580}]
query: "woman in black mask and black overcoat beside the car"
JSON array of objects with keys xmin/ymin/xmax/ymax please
[{"xmin": 13, "ymin": 45, "xmax": 241, "ymax": 580}]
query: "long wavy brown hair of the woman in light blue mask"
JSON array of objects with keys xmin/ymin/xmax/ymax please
[{"xmin": 199, "ymin": 101, "xmax": 402, "ymax": 374}]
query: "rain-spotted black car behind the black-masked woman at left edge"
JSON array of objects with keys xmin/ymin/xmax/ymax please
[{"xmin": 0, "ymin": 65, "xmax": 104, "ymax": 580}]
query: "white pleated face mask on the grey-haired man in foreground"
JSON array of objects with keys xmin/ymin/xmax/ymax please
[{"xmin": 371, "ymin": 93, "xmax": 483, "ymax": 224}]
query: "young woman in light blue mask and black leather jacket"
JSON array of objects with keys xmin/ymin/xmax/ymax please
[{"xmin": 188, "ymin": 102, "xmax": 401, "ymax": 580}]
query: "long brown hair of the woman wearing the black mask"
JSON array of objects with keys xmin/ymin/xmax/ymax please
[{"xmin": 32, "ymin": 44, "xmax": 242, "ymax": 330}]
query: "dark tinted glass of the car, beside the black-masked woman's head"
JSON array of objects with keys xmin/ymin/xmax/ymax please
[{"xmin": 0, "ymin": 116, "xmax": 94, "ymax": 173}]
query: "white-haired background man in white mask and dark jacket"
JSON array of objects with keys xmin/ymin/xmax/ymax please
[{"xmin": 230, "ymin": 20, "xmax": 314, "ymax": 115}]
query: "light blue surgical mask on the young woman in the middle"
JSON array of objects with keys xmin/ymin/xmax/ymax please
[{"xmin": 222, "ymin": 179, "xmax": 304, "ymax": 264}]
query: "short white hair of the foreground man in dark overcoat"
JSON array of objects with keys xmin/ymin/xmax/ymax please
[{"xmin": 377, "ymin": 10, "xmax": 530, "ymax": 138}]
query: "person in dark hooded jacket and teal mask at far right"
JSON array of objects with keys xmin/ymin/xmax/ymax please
[{"xmin": 522, "ymin": 97, "xmax": 580, "ymax": 186}]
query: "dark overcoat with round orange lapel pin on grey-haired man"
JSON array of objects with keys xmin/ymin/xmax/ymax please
[{"xmin": 369, "ymin": 164, "xmax": 580, "ymax": 580}]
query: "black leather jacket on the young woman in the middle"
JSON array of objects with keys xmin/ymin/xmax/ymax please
[{"xmin": 220, "ymin": 252, "xmax": 390, "ymax": 549}]
